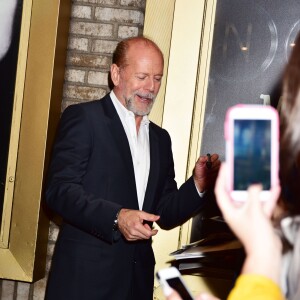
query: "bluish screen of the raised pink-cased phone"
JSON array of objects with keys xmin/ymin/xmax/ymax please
[{"xmin": 233, "ymin": 120, "xmax": 271, "ymax": 191}]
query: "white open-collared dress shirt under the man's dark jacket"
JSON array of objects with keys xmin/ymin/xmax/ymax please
[{"xmin": 110, "ymin": 91, "xmax": 150, "ymax": 210}]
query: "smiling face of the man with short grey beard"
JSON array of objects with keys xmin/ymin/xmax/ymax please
[{"xmin": 114, "ymin": 44, "xmax": 163, "ymax": 116}]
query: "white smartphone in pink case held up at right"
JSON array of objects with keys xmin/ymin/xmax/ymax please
[{"xmin": 224, "ymin": 104, "xmax": 279, "ymax": 202}]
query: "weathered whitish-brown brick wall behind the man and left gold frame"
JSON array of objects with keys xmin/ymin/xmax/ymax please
[{"xmin": 0, "ymin": 0, "xmax": 146, "ymax": 300}]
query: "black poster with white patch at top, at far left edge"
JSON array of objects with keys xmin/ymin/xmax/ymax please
[{"xmin": 0, "ymin": 0, "xmax": 23, "ymax": 215}]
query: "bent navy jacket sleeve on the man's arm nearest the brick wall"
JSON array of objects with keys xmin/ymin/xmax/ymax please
[{"xmin": 45, "ymin": 105, "xmax": 121, "ymax": 242}]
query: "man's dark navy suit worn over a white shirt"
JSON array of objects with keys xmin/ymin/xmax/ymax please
[{"xmin": 46, "ymin": 95, "xmax": 209, "ymax": 300}]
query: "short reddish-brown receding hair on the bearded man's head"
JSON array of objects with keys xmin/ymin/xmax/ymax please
[{"xmin": 112, "ymin": 36, "xmax": 163, "ymax": 67}]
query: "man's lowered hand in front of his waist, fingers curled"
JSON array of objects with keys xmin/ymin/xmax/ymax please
[{"xmin": 118, "ymin": 208, "xmax": 160, "ymax": 241}]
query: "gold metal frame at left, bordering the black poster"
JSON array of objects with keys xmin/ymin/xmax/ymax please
[{"xmin": 0, "ymin": 0, "xmax": 71, "ymax": 282}]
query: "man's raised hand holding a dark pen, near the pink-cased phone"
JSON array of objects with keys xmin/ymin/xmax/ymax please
[{"xmin": 193, "ymin": 154, "xmax": 221, "ymax": 193}]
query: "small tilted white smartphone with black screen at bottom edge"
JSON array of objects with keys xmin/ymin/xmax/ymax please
[{"xmin": 156, "ymin": 267, "xmax": 194, "ymax": 300}]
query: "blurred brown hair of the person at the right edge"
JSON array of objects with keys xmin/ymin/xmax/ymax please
[{"xmin": 280, "ymin": 33, "xmax": 300, "ymax": 214}]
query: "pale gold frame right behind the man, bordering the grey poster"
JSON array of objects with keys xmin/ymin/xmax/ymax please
[{"xmin": 144, "ymin": 0, "xmax": 219, "ymax": 299}]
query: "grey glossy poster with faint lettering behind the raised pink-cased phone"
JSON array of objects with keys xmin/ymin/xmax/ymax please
[{"xmin": 191, "ymin": 0, "xmax": 300, "ymax": 241}]
